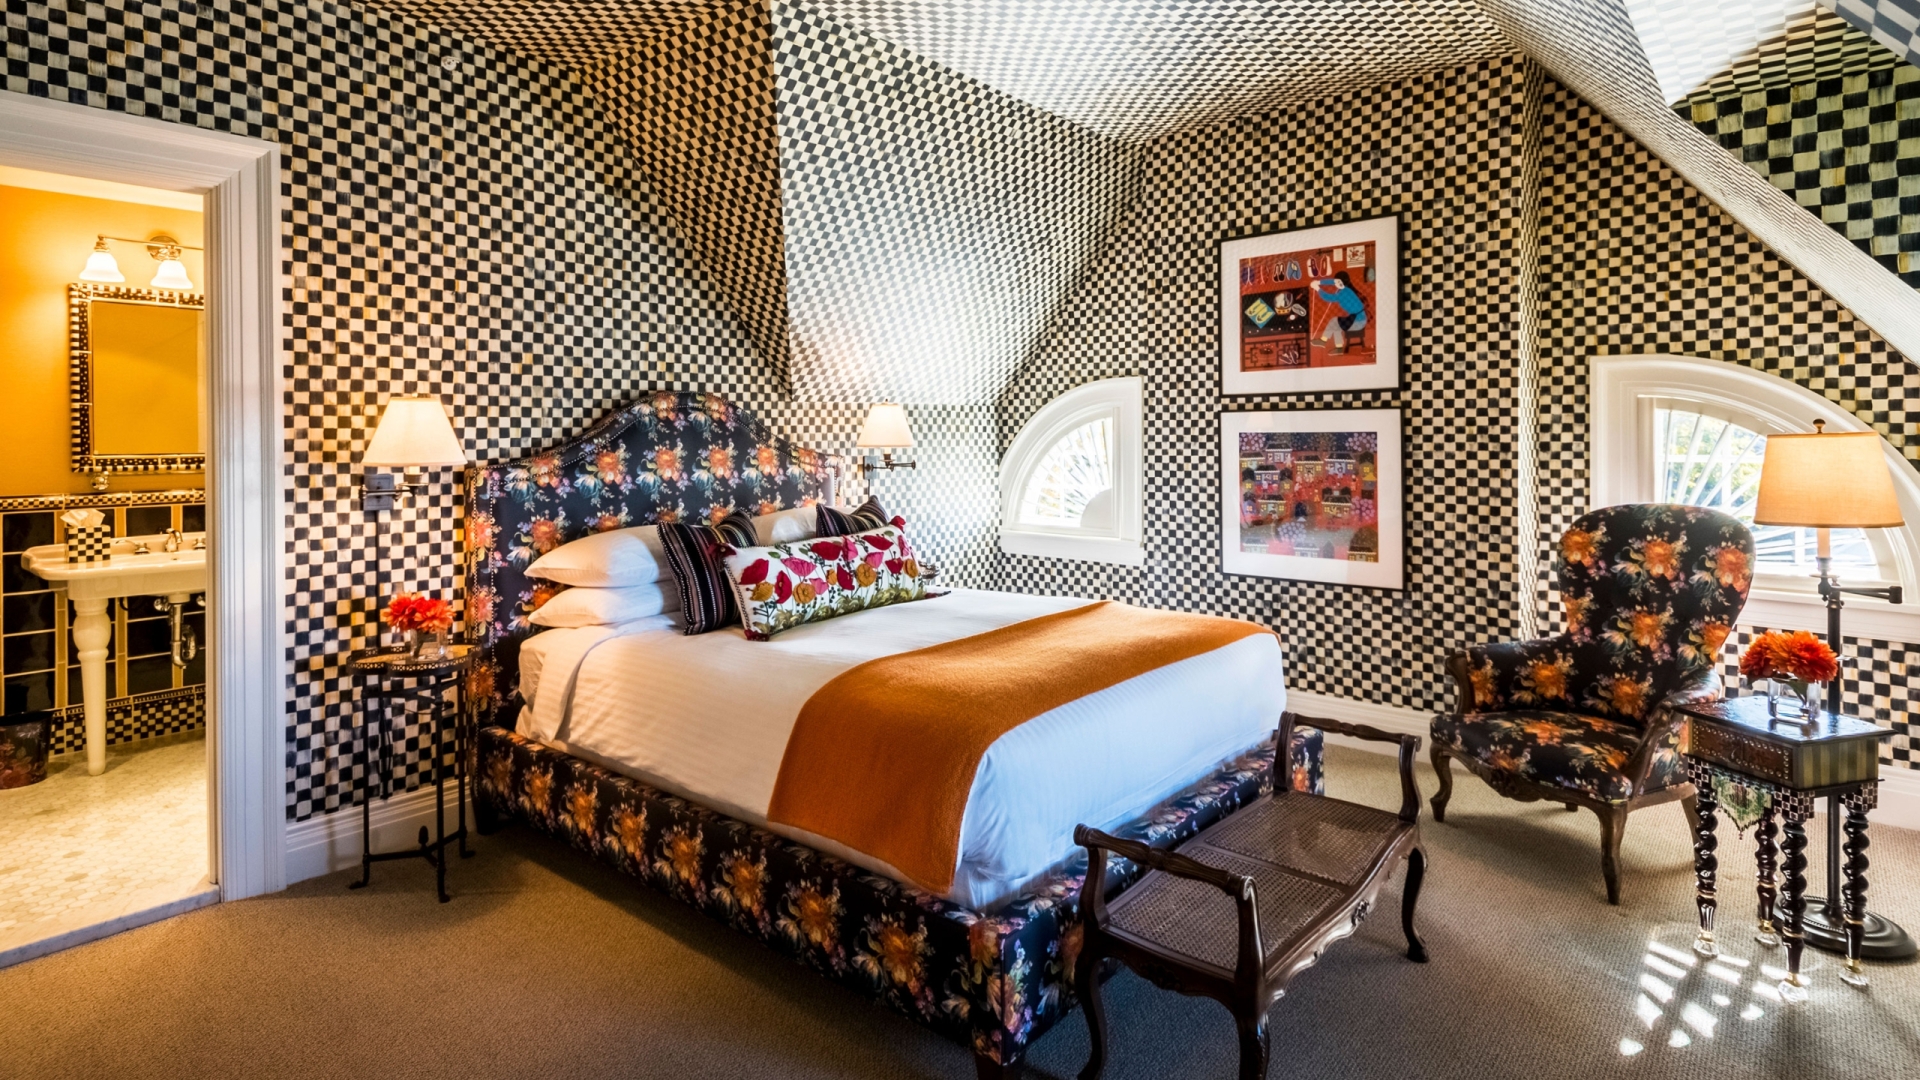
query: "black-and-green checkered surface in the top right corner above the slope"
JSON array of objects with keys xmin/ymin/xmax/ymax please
[{"xmin": 1676, "ymin": 8, "xmax": 1920, "ymax": 286}]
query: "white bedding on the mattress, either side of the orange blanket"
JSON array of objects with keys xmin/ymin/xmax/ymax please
[{"xmin": 520, "ymin": 590, "xmax": 1286, "ymax": 909}]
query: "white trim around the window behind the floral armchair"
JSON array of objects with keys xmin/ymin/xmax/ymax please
[{"xmin": 1588, "ymin": 354, "xmax": 1920, "ymax": 642}]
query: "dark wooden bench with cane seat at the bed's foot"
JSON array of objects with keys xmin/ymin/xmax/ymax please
[{"xmin": 1073, "ymin": 713, "xmax": 1427, "ymax": 1080}]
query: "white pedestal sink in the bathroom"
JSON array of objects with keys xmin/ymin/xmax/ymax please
[{"xmin": 21, "ymin": 534, "xmax": 207, "ymax": 776}]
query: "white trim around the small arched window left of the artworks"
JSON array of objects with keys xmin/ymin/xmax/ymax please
[{"xmin": 1000, "ymin": 375, "xmax": 1146, "ymax": 567}]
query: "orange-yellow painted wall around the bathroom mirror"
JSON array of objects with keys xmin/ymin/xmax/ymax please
[{"xmin": 0, "ymin": 184, "xmax": 207, "ymax": 496}]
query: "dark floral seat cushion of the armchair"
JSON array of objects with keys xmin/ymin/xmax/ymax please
[{"xmin": 1432, "ymin": 709, "xmax": 1680, "ymax": 803}]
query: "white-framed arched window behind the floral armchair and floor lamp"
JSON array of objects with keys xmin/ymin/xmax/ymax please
[{"xmin": 1592, "ymin": 356, "xmax": 1920, "ymax": 640}]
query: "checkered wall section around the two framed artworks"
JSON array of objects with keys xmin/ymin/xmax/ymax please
[{"xmin": 998, "ymin": 58, "xmax": 1530, "ymax": 709}]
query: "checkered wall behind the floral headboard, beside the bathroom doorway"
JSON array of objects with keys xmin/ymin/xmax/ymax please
[{"xmin": 6, "ymin": 0, "xmax": 995, "ymax": 819}]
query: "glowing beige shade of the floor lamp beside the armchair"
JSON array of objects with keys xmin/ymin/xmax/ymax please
[{"xmin": 1753, "ymin": 430, "xmax": 1903, "ymax": 530}]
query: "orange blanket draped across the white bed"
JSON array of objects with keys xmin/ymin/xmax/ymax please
[{"xmin": 766, "ymin": 601, "xmax": 1271, "ymax": 892}]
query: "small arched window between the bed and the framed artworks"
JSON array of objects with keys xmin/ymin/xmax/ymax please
[{"xmin": 1000, "ymin": 379, "xmax": 1146, "ymax": 567}]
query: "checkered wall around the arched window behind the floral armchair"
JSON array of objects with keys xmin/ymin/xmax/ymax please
[{"xmin": 1538, "ymin": 85, "xmax": 1920, "ymax": 765}]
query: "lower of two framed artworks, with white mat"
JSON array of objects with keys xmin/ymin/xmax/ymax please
[{"xmin": 1219, "ymin": 409, "xmax": 1407, "ymax": 588}]
